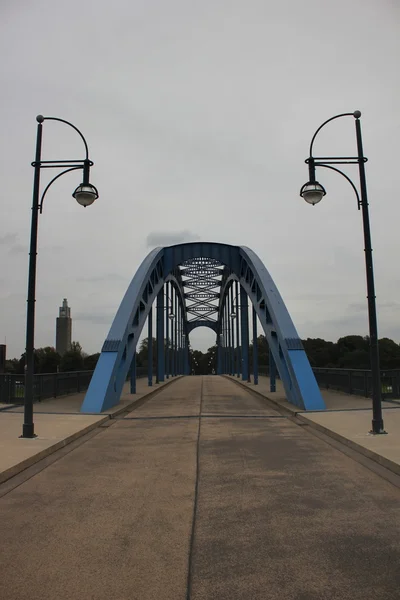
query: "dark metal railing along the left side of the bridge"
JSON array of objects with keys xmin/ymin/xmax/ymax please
[{"xmin": 0, "ymin": 367, "xmax": 147, "ymax": 404}]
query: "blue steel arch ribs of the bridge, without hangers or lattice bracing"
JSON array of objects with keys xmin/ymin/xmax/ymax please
[{"xmin": 81, "ymin": 242, "xmax": 325, "ymax": 413}]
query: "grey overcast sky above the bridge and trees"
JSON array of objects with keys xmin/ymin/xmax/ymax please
[{"xmin": 0, "ymin": 0, "xmax": 400, "ymax": 358}]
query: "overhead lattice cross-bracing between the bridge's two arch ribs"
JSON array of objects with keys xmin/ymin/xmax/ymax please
[{"xmin": 180, "ymin": 257, "xmax": 225, "ymax": 323}]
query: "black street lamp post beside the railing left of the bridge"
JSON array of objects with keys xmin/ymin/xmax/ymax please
[{"xmin": 21, "ymin": 115, "xmax": 99, "ymax": 438}]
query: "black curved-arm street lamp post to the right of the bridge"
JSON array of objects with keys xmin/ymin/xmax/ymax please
[{"xmin": 300, "ymin": 110, "xmax": 386, "ymax": 434}]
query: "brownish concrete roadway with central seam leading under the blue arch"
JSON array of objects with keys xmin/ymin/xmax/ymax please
[{"xmin": 0, "ymin": 376, "xmax": 400, "ymax": 600}]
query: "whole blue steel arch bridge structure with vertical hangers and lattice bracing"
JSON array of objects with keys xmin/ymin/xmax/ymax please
[{"xmin": 81, "ymin": 242, "xmax": 325, "ymax": 413}]
